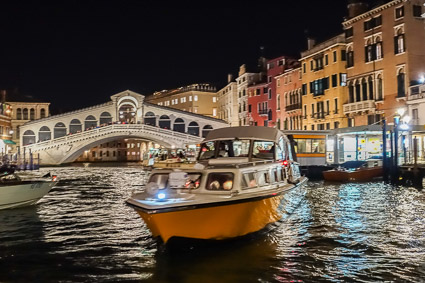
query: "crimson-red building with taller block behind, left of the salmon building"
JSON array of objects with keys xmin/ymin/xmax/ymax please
[{"xmin": 248, "ymin": 56, "xmax": 298, "ymax": 127}]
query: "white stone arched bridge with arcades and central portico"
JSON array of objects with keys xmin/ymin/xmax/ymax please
[{"xmin": 20, "ymin": 90, "xmax": 228, "ymax": 165}]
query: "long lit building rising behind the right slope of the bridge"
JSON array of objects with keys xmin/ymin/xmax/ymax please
[{"xmin": 146, "ymin": 84, "xmax": 218, "ymax": 118}]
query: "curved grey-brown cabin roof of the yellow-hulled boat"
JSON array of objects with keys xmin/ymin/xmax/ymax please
[{"xmin": 204, "ymin": 126, "xmax": 284, "ymax": 142}]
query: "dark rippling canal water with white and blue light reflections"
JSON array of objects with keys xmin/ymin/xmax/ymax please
[{"xmin": 0, "ymin": 167, "xmax": 425, "ymax": 282}]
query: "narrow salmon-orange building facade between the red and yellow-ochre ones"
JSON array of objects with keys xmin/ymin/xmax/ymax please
[{"xmin": 275, "ymin": 67, "xmax": 303, "ymax": 130}]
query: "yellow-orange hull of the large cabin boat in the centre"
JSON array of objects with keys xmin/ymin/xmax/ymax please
[{"xmin": 137, "ymin": 194, "xmax": 284, "ymax": 243}]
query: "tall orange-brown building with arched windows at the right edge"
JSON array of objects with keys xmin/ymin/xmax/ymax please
[{"xmin": 343, "ymin": 0, "xmax": 425, "ymax": 126}]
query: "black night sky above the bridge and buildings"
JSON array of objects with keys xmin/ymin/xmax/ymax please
[{"xmin": 0, "ymin": 0, "xmax": 378, "ymax": 113}]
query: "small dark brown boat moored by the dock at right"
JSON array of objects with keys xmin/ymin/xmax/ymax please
[{"xmin": 323, "ymin": 160, "xmax": 384, "ymax": 182}]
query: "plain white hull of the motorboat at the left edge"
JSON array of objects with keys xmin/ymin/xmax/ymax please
[{"xmin": 0, "ymin": 181, "xmax": 57, "ymax": 209}]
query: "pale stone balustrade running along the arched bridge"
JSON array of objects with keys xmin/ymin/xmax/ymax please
[{"xmin": 26, "ymin": 124, "xmax": 201, "ymax": 151}]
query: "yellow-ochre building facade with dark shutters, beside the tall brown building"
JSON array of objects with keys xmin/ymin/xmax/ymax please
[{"xmin": 300, "ymin": 34, "xmax": 348, "ymax": 130}]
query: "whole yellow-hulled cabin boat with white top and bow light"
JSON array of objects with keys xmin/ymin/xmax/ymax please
[{"xmin": 127, "ymin": 126, "xmax": 307, "ymax": 243}]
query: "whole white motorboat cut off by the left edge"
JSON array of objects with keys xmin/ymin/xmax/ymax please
[{"xmin": 0, "ymin": 173, "xmax": 58, "ymax": 209}]
